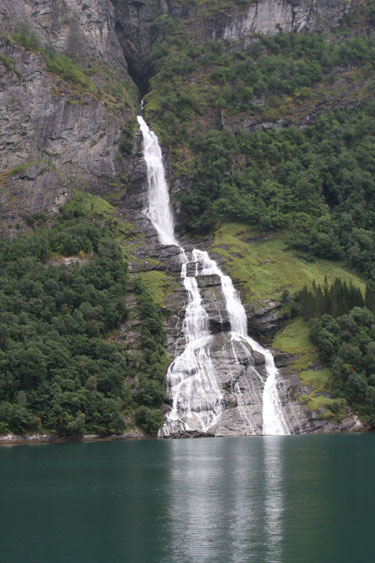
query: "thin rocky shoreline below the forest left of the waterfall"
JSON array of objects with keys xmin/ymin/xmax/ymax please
[{"xmin": 0, "ymin": 431, "xmax": 147, "ymax": 447}]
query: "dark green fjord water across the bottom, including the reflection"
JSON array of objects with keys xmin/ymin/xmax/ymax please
[{"xmin": 0, "ymin": 434, "xmax": 375, "ymax": 563}]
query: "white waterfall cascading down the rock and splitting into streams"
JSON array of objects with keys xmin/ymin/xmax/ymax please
[{"xmin": 137, "ymin": 116, "xmax": 289, "ymax": 436}]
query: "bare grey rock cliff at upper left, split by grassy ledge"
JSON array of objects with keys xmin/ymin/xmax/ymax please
[{"xmin": 0, "ymin": 0, "xmax": 132, "ymax": 233}]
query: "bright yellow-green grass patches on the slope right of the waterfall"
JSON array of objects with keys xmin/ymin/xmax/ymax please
[{"xmin": 212, "ymin": 223, "xmax": 365, "ymax": 419}]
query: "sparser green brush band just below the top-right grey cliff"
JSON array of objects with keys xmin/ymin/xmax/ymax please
[{"xmin": 146, "ymin": 27, "xmax": 375, "ymax": 144}]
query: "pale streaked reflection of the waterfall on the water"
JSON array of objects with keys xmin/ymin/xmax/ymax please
[{"xmin": 165, "ymin": 437, "xmax": 283, "ymax": 563}]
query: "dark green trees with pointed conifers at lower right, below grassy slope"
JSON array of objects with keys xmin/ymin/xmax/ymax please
[{"xmin": 290, "ymin": 278, "xmax": 375, "ymax": 426}]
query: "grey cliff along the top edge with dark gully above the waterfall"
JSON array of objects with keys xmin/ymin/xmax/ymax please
[{"xmin": 111, "ymin": 0, "xmax": 361, "ymax": 76}]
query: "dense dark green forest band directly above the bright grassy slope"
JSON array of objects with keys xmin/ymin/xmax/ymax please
[{"xmin": 177, "ymin": 102, "xmax": 375, "ymax": 279}]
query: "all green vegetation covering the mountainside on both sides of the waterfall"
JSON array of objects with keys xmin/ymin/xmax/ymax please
[{"xmin": 0, "ymin": 0, "xmax": 375, "ymax": 435}]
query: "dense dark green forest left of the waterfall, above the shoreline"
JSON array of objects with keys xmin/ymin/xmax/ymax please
[{"xmin": 0, "ymin": 198, "xmax": 133, "ymax": 436}]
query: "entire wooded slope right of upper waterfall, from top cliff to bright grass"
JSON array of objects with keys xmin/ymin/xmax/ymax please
[{"xmin": 146, "ymin": 18, "xmax": 375, "ymax": 279}]
